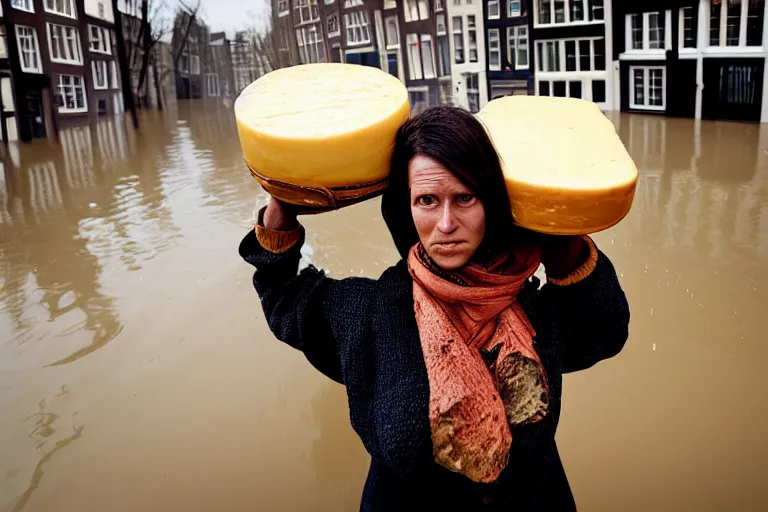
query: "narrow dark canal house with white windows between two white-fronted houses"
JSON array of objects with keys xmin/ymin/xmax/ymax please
[{"xmin": 484, "ymin": 0, "xmax": 535, "ymax": 99}]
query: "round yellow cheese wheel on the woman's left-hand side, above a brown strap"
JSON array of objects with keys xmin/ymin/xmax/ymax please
[{"xmin": 235, "ymin": 64, "xmax": 410, "ymax": 188}]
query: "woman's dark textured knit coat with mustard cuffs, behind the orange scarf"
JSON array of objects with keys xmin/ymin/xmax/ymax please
[{"xmin": 240, "ymin": 231, "xmax": 629, "ymax": 512}]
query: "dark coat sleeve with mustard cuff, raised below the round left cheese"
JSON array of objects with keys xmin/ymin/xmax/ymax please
[{"xmin": 240, "ymin": 231, "xmax": 375, "ymax": 384}]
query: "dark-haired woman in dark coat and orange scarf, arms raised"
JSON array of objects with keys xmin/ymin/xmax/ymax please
[{"xmin": 240, "ymin": 107, "xmax": 629, "ymax": 511}]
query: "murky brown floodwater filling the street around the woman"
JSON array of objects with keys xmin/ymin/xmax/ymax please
[{"xmin": 0, "ymin": 102, "xmax": 768, "ymax": 512}]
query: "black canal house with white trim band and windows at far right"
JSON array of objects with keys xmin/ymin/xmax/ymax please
[{"xmin": 614, "ymin": 0, "xmax": 768, "ymax": 122}]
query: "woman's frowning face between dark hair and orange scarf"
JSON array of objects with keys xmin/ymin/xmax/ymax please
[{"xmin": 408, "ymin": 155, "xmax": 485, "ymax": 270}]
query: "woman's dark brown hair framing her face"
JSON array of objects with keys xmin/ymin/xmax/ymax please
[{"xmin": 381, "ymin": 106, "xmax": 516, "ymax": 258}]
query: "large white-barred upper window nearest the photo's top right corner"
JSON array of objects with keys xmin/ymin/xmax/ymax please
[{"xmin": 709, "ymin": 0, "xmax": 765, "ymax": 46}]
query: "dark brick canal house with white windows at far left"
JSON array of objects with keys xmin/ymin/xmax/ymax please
[{"xmin": 0, "ymin": 0, "xmax": 123, "ymax": 141}]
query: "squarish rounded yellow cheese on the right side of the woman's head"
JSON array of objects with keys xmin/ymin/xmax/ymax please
[{"xmin": 478, "ymin": 96, "xmax": 637, "ymax": 235}]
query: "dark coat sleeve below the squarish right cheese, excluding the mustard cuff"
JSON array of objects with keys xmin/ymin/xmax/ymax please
[{"xmin": 540, "ymin": 244, "xmax": 629, "ymax": 373}]
